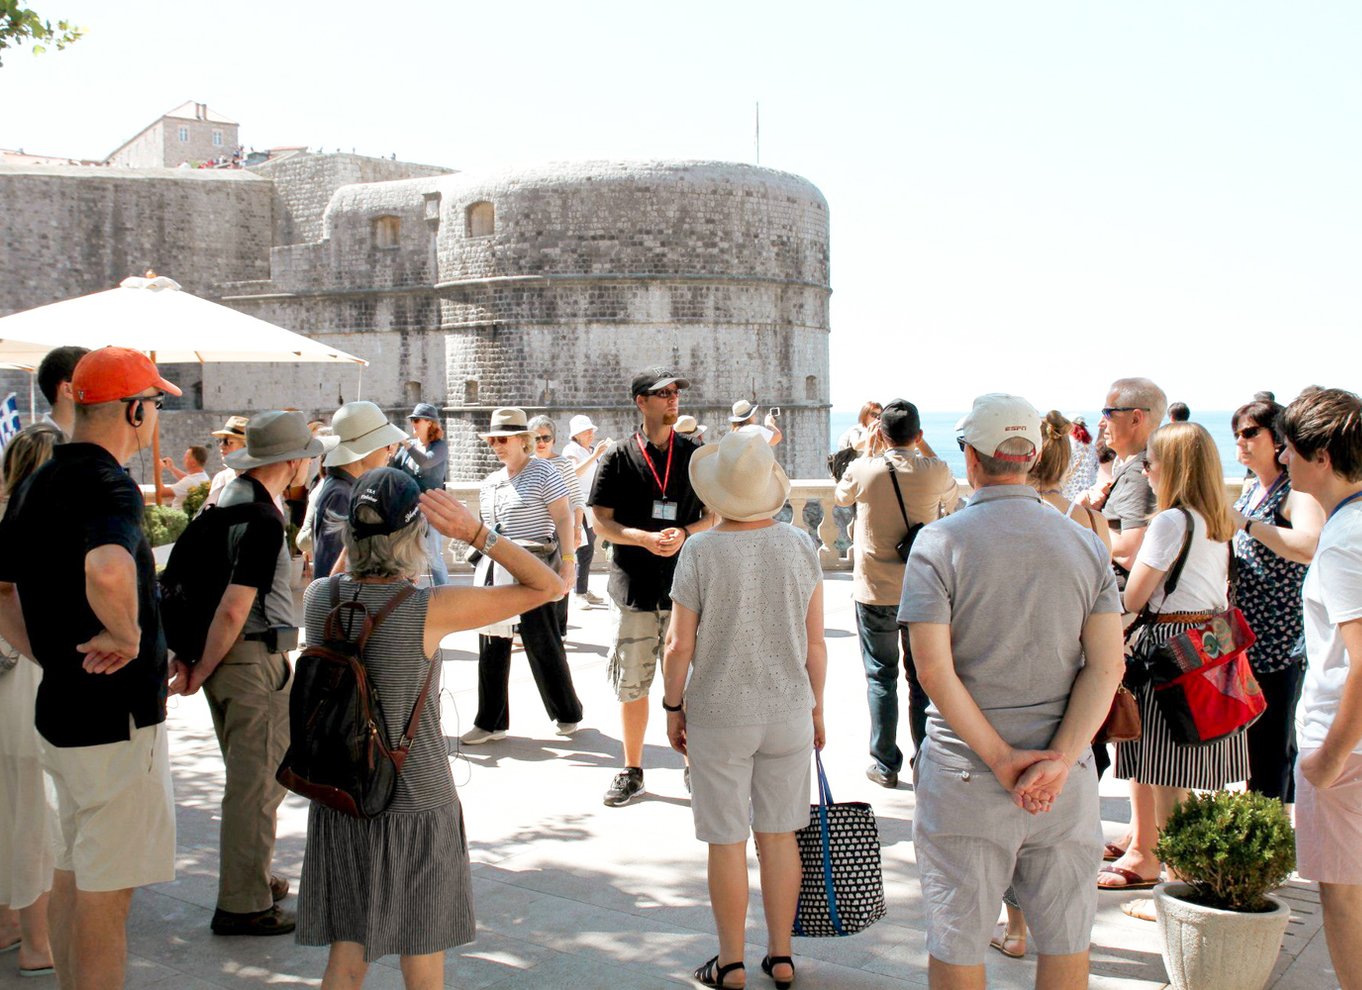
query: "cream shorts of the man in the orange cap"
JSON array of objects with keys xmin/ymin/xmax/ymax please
[{"xmin": 38, "ymin": 723, "xmax": 174, "ymax": 891}]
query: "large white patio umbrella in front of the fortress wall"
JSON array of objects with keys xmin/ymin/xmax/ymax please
[{"xmin": 0, "ymin": 272, "xmax": 369, "ymax": 504}]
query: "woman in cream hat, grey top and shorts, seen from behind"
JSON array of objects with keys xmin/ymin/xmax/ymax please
[{"xmin": 662, "ymin": 432, "xmax": 827, "ymax": 987}]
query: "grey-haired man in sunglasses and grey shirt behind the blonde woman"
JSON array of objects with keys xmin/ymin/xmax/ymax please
[{"xmin": 1102, "ymin": 379, "xmax": 1169, "ymax": 586}]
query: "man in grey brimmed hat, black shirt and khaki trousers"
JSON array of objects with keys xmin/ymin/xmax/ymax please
[{"xmin": 172, "ymin": 411, "xmax": 321, "ymax": 936}]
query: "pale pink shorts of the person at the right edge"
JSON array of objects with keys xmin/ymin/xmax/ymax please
[{"xmin": 1295, "ymin": 749, "xmax": 1362, "ymax": 884}]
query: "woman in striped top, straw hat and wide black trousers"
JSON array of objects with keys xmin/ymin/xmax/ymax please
[{"xmin": 459, "ymin": 407, "xmax": 582, "ymax": 746}]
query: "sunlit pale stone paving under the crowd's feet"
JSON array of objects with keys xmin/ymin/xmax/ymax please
[{"xmin": 0, "ymin": 575, "xmax": 1337, "ymax": 990}]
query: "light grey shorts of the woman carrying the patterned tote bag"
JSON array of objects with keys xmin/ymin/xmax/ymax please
[{"xmin": 686, "ymin": 715, "xmax": 813, "ymax": 844}]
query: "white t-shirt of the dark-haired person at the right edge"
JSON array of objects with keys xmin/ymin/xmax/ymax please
[{"xmin": 1295, "ymin": 501, "xmax": 1362, "ymax": 753}]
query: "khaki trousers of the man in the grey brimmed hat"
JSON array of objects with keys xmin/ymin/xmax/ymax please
[{"xmin": 203, "ymin": 640, "xmax": 293, "ymax": 914}]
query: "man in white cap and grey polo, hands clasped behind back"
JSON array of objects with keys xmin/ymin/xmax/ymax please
[{"xmin": 899, "ymin": 395, "xmax": 1122, "ymax": 990}]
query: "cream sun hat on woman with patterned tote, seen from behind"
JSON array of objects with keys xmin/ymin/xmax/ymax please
[{"xmin": 691, "ymin": 433, "xmax": 790, "ymax": 523}]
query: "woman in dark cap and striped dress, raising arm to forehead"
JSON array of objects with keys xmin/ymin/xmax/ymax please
[{"xmin": 297, "ymin": 467, "xmax": 563, "ymax": 990}]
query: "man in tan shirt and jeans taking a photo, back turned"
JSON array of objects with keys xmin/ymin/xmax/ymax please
[{"xmin": 836, "ymin": 399, "xmax": 960, "ymax": 787}]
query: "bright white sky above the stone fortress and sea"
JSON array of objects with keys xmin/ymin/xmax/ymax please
[{"xmin": 0, "ymin": 0, "xmax": 1362, "ymax": 410}]
